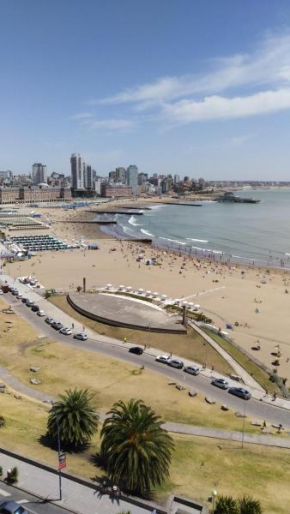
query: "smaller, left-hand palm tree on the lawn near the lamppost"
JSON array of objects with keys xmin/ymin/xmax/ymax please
[{"xmin": 47, "ymin": 389, "xmax": 99, "ymax": 449}]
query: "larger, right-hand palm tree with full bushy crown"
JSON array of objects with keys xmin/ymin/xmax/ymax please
[{"xmin": 101, "ymin": 400, "xmax": 174, "ymax": 495}]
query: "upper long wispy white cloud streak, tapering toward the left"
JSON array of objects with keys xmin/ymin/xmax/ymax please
[{"xmin": 97, "ymin": 33, "xmax": 290, "ymax": 109}]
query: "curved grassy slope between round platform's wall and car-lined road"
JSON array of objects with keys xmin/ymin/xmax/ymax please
[{"xmin": 49, "ymin": 296, "xmax": 233, "ymax": 374}]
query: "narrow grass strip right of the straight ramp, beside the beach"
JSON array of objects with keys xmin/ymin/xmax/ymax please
[{"xmin": 203, "ymin": 329, "xmax": 281, "ymax": 396}]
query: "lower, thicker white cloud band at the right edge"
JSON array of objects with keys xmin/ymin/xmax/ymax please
[{"xmin": 162, "ymin": 88, "xmax": 290, "ymax": 123}]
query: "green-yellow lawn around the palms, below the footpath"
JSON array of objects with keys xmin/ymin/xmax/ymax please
[{"xmin": 0, "ymin": 395, "xmax": 290, "ymax": 514}]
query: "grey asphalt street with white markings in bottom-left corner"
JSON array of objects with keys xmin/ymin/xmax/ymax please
[{"xmin": 0, "ymin": 482, "xmax": 72, "ymax": 514}]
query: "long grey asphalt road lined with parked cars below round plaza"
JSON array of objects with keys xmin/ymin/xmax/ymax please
[{"xmin": 5, "ymin": 293, "xmax": 290, "ymax": 428}]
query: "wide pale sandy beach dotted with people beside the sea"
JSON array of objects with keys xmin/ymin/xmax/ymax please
[{"xmin": 5, "ymin": 200, "xmax": 290, "ymax": 378}]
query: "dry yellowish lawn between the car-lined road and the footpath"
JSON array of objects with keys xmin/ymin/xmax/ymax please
[{"xmin": 0, "ymin": 296, "xmax": 274, "ymax": 433}]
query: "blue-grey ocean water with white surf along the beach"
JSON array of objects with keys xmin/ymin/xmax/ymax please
[{"xmin": 104, "ymin": 189, "xmax": 290, "ymax": 268}]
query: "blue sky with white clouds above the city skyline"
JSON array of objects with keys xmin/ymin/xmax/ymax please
[{"xmin": 0, "ymin": 0, "xmax": 290, "ymax": 180}]
